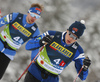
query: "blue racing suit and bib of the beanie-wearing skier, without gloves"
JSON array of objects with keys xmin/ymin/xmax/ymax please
[{"xmin": 26, "ymin": 31, "xmax": 88, "ymax": 82}]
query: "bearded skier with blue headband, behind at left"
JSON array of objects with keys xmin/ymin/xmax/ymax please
[{"xmin": 0, "ymin": 3, "xmax": 43, "ymax": 79}]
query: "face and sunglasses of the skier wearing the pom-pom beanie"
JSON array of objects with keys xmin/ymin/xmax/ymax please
[{"xmin": 65, "ymin": 30, "xmax": 77, "ymax": 44}]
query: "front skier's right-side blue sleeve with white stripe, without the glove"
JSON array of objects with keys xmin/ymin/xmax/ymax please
[{"xmin": 73, "ymin": 46, "xmax": 88, "ymax": 80}]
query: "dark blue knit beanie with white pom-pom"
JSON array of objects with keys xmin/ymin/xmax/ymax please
[{"xmin": 68, "ymin": 20, "xmax": 86, "ymax": 38}]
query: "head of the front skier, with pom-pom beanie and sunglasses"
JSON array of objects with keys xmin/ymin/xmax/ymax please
[{"xmin": 65, "ymin": 20, "xmax": 86, "ymax": 44}]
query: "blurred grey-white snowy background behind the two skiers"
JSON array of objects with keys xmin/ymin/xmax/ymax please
[{"xmin": 0, "ymin": 0, "xmax": 100, "ymax": 82}]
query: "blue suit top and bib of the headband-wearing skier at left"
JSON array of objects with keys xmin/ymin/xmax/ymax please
[{"xmin": 0, "ymin": 12, "xmax": 40, "ymax": 60}]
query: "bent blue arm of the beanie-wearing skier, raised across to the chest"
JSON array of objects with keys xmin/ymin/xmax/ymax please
[{"xmin": 25, "ymin": 31, "xmax": 56, "ymax": 50}]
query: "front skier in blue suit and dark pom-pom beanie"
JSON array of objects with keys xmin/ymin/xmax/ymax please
[{"xmin": 24, "ymin": 21, "xmax": 91, "ymax": 82}]
